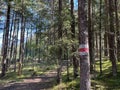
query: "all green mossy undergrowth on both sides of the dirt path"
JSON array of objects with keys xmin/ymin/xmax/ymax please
[{"xmin": 0, "ymin": 60, "xmax": 120, "ymax": 90}]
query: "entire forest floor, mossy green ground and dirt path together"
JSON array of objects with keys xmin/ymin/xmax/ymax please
[{"xmin": 0, "ymin": 60, "xmax": 120, "ymax": 90}]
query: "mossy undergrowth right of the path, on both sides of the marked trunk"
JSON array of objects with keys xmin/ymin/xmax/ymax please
[{"xmin": 53, "ymin": 60, "xmax": 120, "ymax": 90}]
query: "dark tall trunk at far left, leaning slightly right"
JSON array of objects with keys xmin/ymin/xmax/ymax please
[{"xmin": 1, "ymin": 2, "xmax": 10, "ymax": 77}]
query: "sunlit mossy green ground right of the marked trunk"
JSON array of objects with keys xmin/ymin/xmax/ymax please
[{"xmin": 92, "ymin": 60, "xmax": 120, "ymax": 90}]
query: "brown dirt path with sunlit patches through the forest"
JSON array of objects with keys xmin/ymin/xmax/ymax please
[{"xmin": 0, "ymin": 71, "xmax": 56, "ymax": 90}]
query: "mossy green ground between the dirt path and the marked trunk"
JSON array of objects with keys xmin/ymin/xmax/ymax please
[{"xmin": 52, "ymin": 67, "xmax": 80, "ymax": 90}]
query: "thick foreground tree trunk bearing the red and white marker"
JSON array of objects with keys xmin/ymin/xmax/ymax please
[{"xmin": 78, "ymin": 0, "xmax": 90, "ymax": 90}]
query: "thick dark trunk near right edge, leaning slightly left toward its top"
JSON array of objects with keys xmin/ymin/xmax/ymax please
[{"xmin": 109, "ymin": 0, "xmax": 117, "ymax": 76}]
